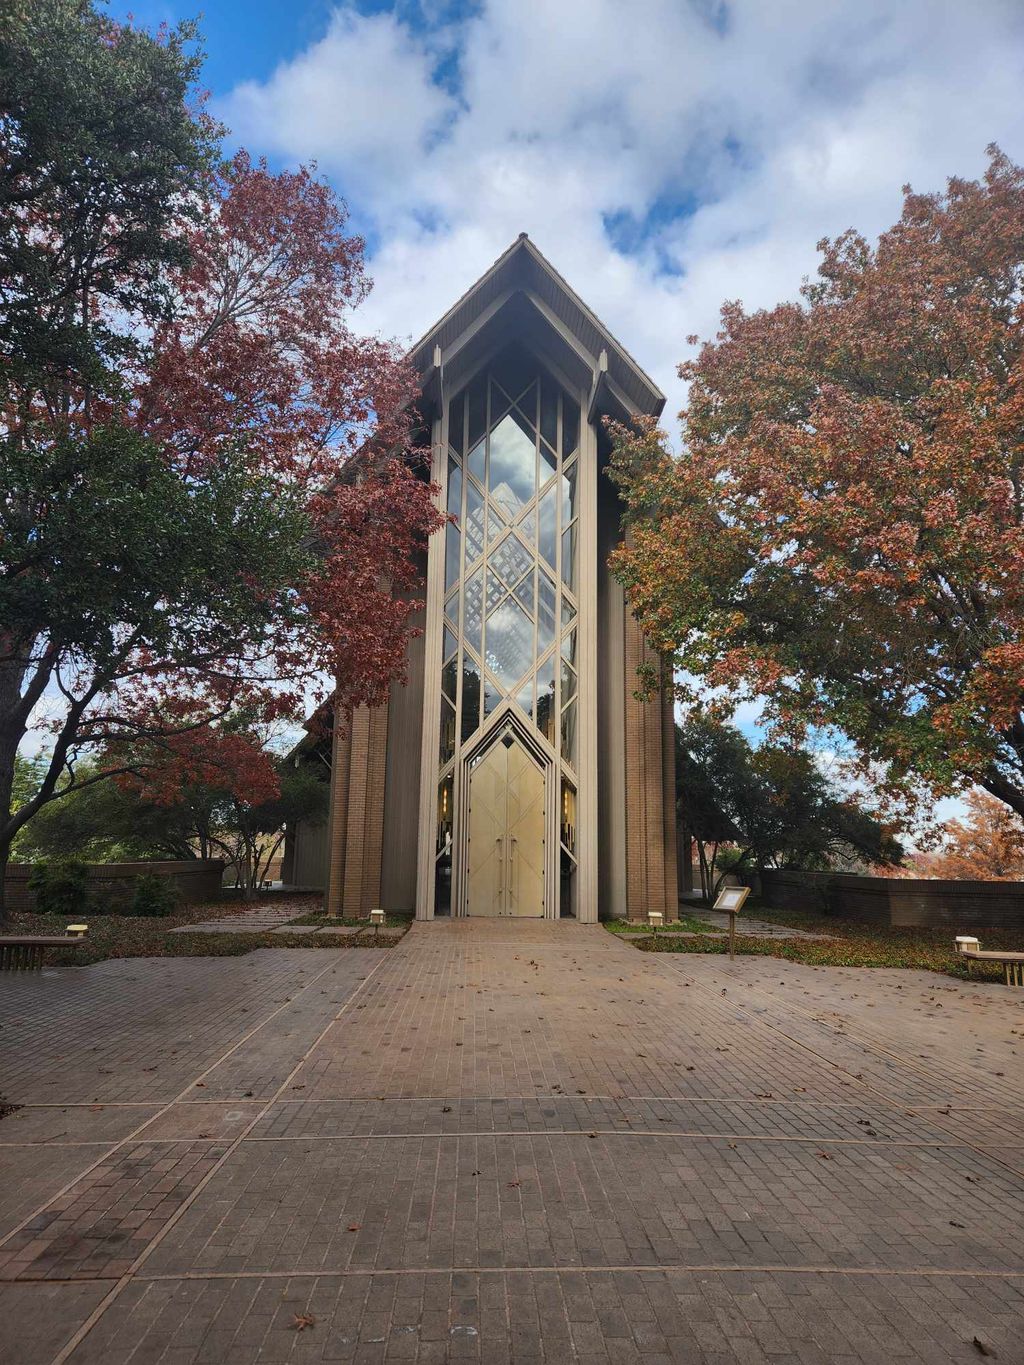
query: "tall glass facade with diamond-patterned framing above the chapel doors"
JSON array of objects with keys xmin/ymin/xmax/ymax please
[{"xmin": 437, "ymin": 347, "xmax": 580, "ymax": 910}]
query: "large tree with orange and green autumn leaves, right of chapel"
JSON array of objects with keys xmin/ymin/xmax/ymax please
[{"xmin": 614, "ymin": 147, "xmax": 1024, "ymax": 814}]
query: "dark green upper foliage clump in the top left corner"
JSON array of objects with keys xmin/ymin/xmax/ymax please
[{"xmin": 0, "ymin": 0, "xmax": 217, "ymax": 404}]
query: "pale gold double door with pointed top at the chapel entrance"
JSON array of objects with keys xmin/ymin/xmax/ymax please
[{"xmin": 466, "ymin": 728, "xmax": 546, "ymax": 917}]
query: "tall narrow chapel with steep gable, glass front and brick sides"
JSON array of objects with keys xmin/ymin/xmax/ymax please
[{"xmin": 285, "ymin": 233, "xmax": 679, "ymax": 921}]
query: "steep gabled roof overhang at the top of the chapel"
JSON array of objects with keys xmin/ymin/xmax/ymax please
[{"xmin": 408, "ymin": 232, "xmax": 665, "ymax": 416}]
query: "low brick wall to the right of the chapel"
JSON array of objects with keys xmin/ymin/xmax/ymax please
[{"xmin": 760, "ymin": 870, "xmax": 1024, "ymax": 934}]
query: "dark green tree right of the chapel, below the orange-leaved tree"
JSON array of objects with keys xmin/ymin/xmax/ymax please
[{"xmin": 676, "ymin": 711, "xmax": 902, "ymax": 900}]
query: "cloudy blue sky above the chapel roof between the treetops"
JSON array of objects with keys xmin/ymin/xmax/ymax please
[{"xmin": 218, "ymin": 0, "xmax": 1024, "ymax": 418}]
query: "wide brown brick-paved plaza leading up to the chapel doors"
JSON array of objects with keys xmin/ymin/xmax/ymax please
[{"xmin": 0, "ymin": 920, "xmax": 1024, "ymax": 1365}]
